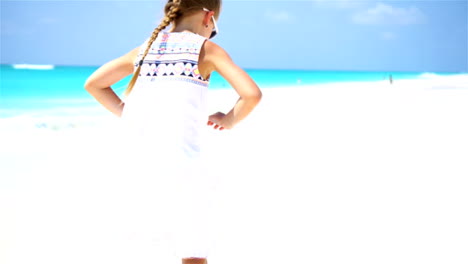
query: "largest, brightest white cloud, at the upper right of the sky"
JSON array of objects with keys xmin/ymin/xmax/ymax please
[{"xmin": 352, "ymin": 3, "xmax": 426, "ymax": 25}]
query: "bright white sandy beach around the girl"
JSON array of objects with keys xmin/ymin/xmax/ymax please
[{"xmin": 0, "ymin": 75, "xmax": 468, "ymax": 264}]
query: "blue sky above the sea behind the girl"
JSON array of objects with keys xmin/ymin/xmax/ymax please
[{"xmin": 1, "ymin": 0, "xmax": 468, "ymax": 72}]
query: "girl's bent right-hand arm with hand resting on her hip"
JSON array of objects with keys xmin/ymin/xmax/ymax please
[{"xmin": 203, "ymin": 41, "xmax": 262, "ymax": 130}]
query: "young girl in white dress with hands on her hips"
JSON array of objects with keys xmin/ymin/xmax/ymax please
[{"xmin": 85, "ymin": 0, "xmax": 262, "ymax": 264}]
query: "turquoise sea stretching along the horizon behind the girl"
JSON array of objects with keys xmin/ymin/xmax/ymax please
[{"xmin": 0, "ymin": 65, "xmax": 464, "ymax": 118}]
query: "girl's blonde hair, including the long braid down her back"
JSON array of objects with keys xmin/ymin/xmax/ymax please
[{"xmin": 124, "ymin": 0, "xmax": 221, "ymax": 95}]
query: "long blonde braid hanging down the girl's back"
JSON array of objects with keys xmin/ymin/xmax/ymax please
[{"xmin": 124, "ymin": 0, "xmax": 181, "ymax": 96}]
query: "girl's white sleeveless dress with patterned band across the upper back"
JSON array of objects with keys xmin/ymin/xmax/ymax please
[{"xmin": 122, "ymin": 32, "xmax": 216, "ymax": 258}]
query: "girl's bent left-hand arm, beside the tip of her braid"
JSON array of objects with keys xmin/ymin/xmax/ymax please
[{"xmin": 84, "ymin": 47, "xmax": 139, "ymax": 117}]
